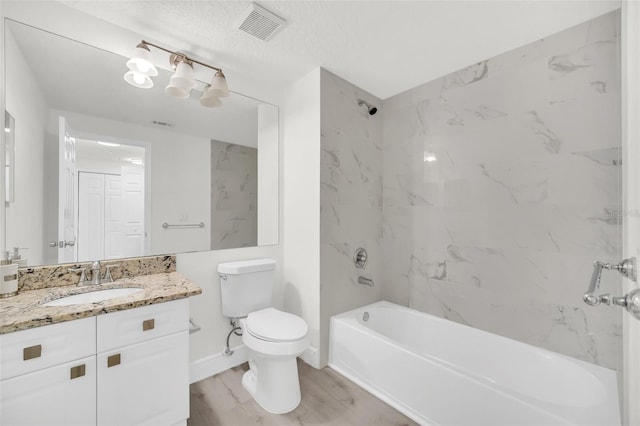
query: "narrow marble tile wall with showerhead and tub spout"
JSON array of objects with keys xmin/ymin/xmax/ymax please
[{"xmin": 320, "ymin": 69, "xmax": 383, "ymax": 365}]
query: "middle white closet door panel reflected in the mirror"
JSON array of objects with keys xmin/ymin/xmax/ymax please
[{"xmin": 104, "ymin": 175, "xmax": 125, "ymax": 259}]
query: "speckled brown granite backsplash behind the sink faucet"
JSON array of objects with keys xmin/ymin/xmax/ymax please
[{"xmin": 18, "ymin": 256, "xmax": 176, "ymax": 292}]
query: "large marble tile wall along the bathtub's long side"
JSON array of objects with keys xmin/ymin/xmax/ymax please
[{"xmin": 383, "ymin": 12, "xmax": 622, "ymax": 368}]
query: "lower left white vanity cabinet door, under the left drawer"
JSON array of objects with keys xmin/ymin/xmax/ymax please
[{"xmin": 0, "ymin": 356, "xmax": 96, "ymax": 426}]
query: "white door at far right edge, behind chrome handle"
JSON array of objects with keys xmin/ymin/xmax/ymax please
[{"xmin": 621, "ymin": 1, "xmax": 640, "ymax": 425}]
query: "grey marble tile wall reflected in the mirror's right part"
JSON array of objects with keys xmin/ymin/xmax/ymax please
[{"xmin": 211, "ymin": 140, "xmax": 258, "ymax": 250}]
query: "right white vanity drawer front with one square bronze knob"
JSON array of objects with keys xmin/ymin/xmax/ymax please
[{"xmin": 97, "ymin": 299, "xmax": 189, "ymax": 353}]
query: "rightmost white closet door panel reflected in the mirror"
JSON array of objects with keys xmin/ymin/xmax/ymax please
[{"xmin": 121, "ymin": 166, "xmax": 146, "ymax": 257}]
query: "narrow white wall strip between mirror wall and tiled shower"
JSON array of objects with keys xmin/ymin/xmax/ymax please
[{"xmin": 283, "ymin": 68, "xmax": 320, "ymax": 367}]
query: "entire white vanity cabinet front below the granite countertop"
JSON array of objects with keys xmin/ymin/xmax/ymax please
[{"xmin": 0, "ymin": 299, "xmax": 189, "ymax": 426}]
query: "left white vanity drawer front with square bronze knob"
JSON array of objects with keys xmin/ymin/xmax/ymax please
[{"xmin": 0, "ymin": 317, "xmax": 96, "ymax": 380}]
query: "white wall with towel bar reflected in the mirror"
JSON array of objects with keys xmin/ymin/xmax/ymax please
[{"xmin": 50, "ymin": 110, "xmax": 211, "ymax": 254}]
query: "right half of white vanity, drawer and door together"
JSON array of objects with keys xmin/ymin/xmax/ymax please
[{"xmin": 97, "ymin": 299, "xmax": 189, "ymax": 426}]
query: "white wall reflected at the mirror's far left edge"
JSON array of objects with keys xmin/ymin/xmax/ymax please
[{"xmin": 1, "ymin": 27, "xmax": 47, "ymax": 264}]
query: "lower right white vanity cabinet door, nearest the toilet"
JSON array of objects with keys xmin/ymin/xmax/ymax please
[{"xmin": 97, "ymin": 331, "xmax": 189, "ymax": 426}]
